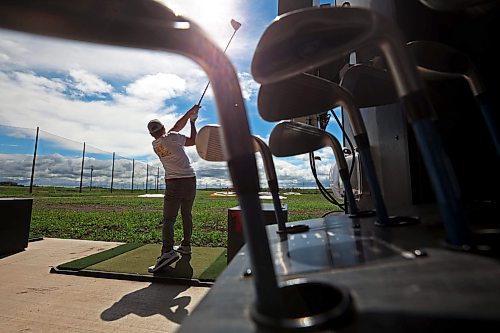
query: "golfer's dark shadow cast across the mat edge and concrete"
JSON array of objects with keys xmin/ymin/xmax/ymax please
[{"xmin": 101, "ymin": 255, "xmax": 193, "ymax": 324}]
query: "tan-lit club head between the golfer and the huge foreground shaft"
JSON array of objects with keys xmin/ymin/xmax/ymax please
[{"xmin": 196, "ymin": 125, "xmax": 227, "ymax": 162}]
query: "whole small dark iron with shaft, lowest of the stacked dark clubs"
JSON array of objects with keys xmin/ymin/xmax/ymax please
[{"xmin": 269, "ymin": 121, "xmax": 359, "ymax": 215}]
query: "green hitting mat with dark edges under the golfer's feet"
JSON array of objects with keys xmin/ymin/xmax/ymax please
[{"xmin": 51, "ymin": 244, "xmax": 227, "ymax": 286}]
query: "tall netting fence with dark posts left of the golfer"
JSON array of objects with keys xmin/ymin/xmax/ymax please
[{"xmin": 0, "ymin": 125, "xmax": 165, "ymax": 193}]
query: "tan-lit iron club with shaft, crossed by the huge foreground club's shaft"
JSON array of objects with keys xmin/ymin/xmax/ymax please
[{"xmin": 196, "ymin": 125, "xmax": 286, "ymax": 231}]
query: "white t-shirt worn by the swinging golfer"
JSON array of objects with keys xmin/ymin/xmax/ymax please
[{"xmin": 153, "ymin": 132, "xmax": 195, "ymax": 179}]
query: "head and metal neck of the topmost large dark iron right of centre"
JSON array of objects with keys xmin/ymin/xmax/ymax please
[{"xmin": 252, "ymin": 7, "xmax": 423, "ymax": 98}]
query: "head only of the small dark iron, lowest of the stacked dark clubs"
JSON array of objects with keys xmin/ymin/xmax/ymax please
[{"xmin": 269, "ymin": 121, "xmax": 328, "ymax": 157}]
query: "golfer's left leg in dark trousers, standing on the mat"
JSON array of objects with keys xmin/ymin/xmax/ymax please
[{"xmin": 161, "ymin": 181, "xmax": 181, "ymax": 253}]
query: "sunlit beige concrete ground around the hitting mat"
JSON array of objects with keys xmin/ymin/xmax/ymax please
[{"xmin": 0, "ymin": 238, "xmax": 209, "ymax": 333}]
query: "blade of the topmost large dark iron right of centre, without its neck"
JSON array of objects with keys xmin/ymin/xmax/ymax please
[{"xmin": 252, "ymin": 7, "xmax": 388, "ymax": 84}]
